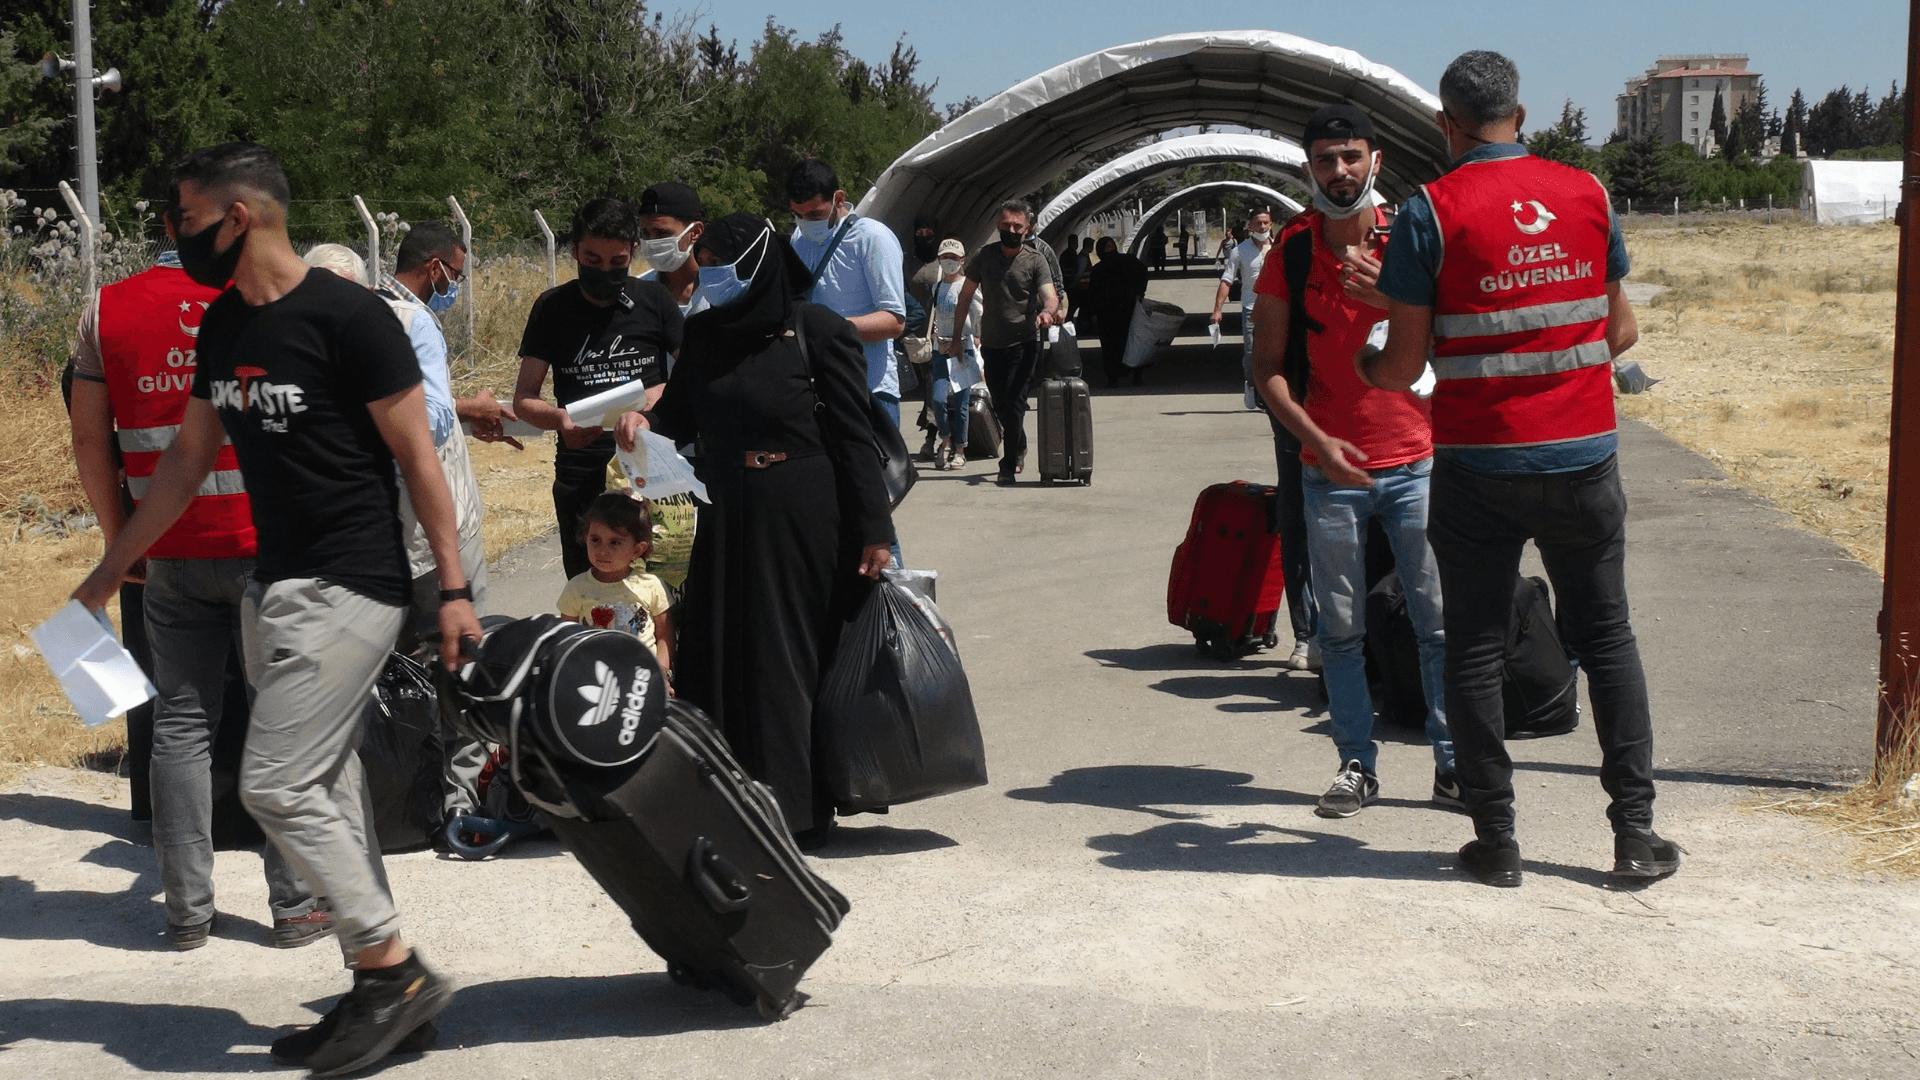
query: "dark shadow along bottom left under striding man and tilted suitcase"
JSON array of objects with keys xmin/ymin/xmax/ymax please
[{"xmin": 0, "ymin": 972, "xmax": 762, "ymax": 1076}]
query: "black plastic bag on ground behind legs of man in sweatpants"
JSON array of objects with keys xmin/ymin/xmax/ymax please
[{"xmin": 359, "ymin": 653, "xmax": 442, "ymax": 855}]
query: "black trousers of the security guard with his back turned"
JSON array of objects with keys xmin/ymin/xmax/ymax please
[{"xmin": 1427, "ymin": 449, "xmax": 1653, "ymax": 838}]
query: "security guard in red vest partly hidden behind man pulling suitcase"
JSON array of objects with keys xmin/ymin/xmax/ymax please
[{"xmin": 71, "ymin": 219, "xmax": 332, "ymax": 949}]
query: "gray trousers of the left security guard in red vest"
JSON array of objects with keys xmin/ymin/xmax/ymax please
[{"xmin": 144, "ymin": 559, "xmax": 315, "ymax": 926}]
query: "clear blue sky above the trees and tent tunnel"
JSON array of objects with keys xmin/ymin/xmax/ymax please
[{"xmin": 683, "ymin": 0, "xmax": 1907, "ymax": 140}]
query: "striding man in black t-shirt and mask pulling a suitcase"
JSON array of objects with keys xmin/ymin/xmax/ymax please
[{"xmin": 73, "ymin": 142, "xmax": 480, "ymax": 1076}]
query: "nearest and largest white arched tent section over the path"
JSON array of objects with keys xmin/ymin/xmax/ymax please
[{"xmin": 860, "ymin": 31, "xmax": 1448, "ymax": 244}]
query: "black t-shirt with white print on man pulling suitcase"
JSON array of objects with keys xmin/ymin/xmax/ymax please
[{"xmin": 192, "ymin": 269, "xmax": 420, "ymax": 607}]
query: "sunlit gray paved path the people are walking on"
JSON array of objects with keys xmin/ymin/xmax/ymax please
[{"xmin": 0, "ymin": 292, "xmax": 1920, "ymax": 1080}]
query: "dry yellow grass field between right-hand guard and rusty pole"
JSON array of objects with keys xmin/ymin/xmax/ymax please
[{"xmin": 1620, "ymin": 223, "xmax": 1899, "ymax": 571}]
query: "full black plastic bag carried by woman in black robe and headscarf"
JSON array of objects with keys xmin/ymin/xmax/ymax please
[{"xmin": 814, "ymin": 582, "xmax": 987, "ymax": 813}]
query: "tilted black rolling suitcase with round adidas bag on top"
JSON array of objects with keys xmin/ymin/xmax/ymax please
[{"xmin": 453, "ymin": 615, "xmax": 849, "ymax": 1020}]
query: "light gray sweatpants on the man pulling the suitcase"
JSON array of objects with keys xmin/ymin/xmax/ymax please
[{"xmin": 240, "ymin": 578, "xmax": 407, "ymax": 961}]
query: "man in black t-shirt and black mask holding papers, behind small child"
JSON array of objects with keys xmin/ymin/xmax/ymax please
[{"xmin": 513, "ymin": 198, "xmax": 684, "ymax": 578}]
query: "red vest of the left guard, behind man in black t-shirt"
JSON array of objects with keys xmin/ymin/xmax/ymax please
[{"xmin": 98, "ymin": 267, "xmax": 253, "ymax": 559}]
